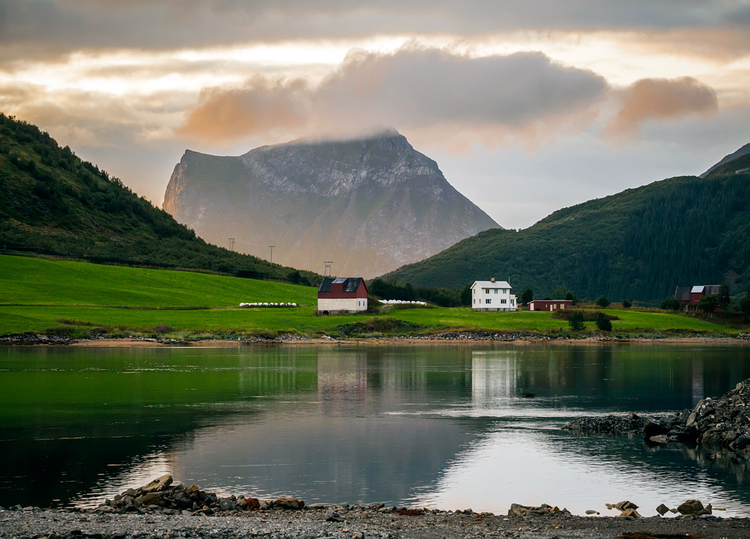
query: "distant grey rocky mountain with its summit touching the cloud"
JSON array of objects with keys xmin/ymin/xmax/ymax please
[{"xmin": 163, "ymin": 132, "xmax": 498, "ymax": 277}]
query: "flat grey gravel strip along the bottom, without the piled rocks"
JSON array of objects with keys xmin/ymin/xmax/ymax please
[{"xmin": 0, "ymin": 506, "xmax": 750, "ymax": 539}]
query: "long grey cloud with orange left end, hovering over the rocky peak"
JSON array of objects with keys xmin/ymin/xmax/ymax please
[{"xmin": 178, "ymin": 47, "xmax": 608, "ymax": 144}]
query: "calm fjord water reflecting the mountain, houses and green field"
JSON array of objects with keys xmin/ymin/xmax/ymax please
[{"xmin": 0, "ymin": 345, "xmax": 750, "ymax": 516}]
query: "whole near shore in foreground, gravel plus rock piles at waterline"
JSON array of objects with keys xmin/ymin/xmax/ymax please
[{"xmin": 0, "ymin": 475, "xmax": 750, "ymax": 539}]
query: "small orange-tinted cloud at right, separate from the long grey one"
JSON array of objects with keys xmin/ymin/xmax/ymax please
[{"xmin": 605, "ymin": 77, "xmax": 719, "ymax": 138}]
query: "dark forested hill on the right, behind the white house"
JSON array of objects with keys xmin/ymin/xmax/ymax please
[{"xmin": 383, "ymin": 151, "xmax": 750, "ymax": 304}]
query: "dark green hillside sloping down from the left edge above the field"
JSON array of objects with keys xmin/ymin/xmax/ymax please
[{"xmin": 0, "ymin": 114, "xmax": 317, "ymax": 282}]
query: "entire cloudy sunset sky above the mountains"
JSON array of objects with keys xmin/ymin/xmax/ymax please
[{"xmin": 0, "ymin": 0, "xmax": 750, "ymax": 228}]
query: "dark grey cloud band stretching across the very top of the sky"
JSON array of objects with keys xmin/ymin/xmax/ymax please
[{"xmin": 0, "ymin": 0, "xmax": 745, "ymax": 52}]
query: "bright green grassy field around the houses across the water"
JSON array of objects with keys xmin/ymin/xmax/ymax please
[{"xmin": 0, "ymin": 256, "xmax": 738, "ymax": 338}]
